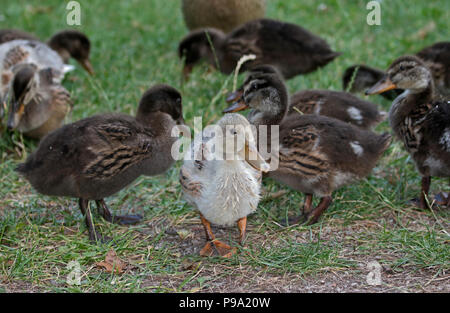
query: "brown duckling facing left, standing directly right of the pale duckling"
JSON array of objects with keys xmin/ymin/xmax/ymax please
[{"xmin": 224, "ymin": 74, "xmax": 391, "ymax": 224}]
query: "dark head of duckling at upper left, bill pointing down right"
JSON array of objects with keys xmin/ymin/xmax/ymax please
[{"xmin": 48, "ymin": 30, "xmax": 94, "ymax": 75}]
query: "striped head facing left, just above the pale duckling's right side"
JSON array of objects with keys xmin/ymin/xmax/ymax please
[{"xmin": 223, "ymin": 74, "xmax": 289, "ymax": 125}]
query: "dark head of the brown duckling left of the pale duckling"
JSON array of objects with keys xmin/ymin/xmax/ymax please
[{"xmin": 136, "ymin": 84, "xmax": 184, "ymax": 125}]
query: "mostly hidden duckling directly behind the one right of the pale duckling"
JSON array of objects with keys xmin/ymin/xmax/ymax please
[{"xmin": 227, "ymin": 64, "xmax": 387, "ymax": 129}]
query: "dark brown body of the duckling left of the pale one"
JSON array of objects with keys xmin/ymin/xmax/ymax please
[{"xmin": 17, "ymin": 114, "xmax": 153, "ymax": 200}]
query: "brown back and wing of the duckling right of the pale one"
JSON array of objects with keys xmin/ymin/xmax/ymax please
[{"xmin": 280, "ymin": 114, "xmax": 391, "ymax": 177}]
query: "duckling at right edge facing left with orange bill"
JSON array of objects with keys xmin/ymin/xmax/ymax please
[{"xmin": 366, "ymin": 56, "xmax": 450, "ymax": 209}]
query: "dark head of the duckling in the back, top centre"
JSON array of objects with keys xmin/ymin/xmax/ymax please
[{"xmin": 178, "ymin": 28, "xmax": 225, "ymax": 80}]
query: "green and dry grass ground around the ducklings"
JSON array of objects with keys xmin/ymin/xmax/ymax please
[{"xmin": 0, "ymin": 0, "xmax": 450, "ymax": 292}]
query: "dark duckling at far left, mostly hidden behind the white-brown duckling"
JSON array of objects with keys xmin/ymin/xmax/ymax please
[{"xmin": 0, "ymin": 29, "xmax": 94, "ymax": 75}]
